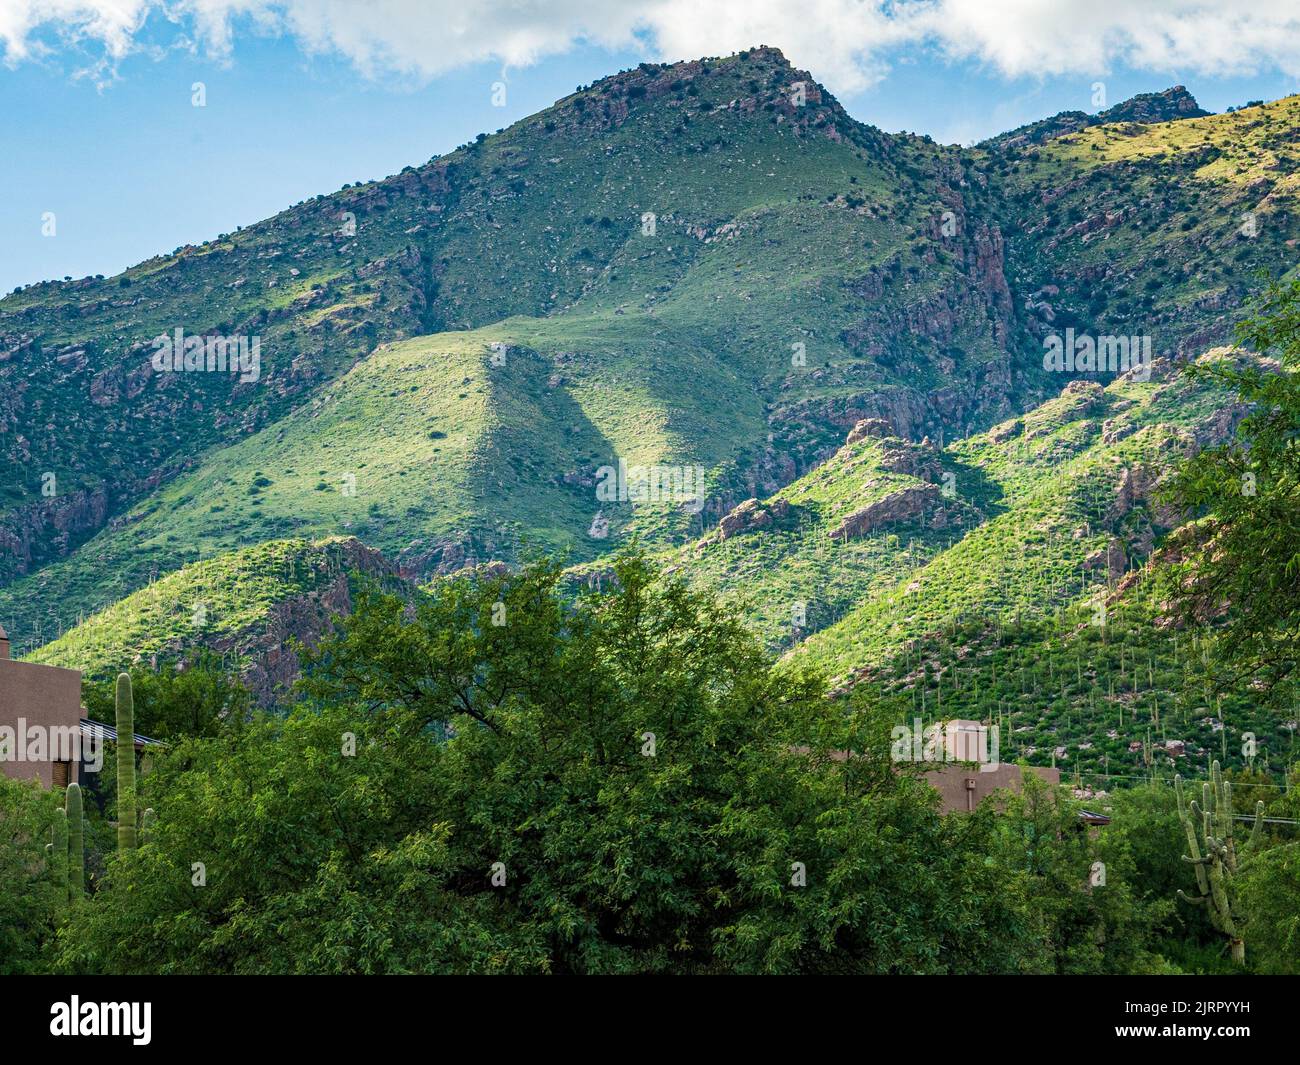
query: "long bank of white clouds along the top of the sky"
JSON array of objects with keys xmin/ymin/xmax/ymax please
[{"xmin": 0, "ymin": 0, "xmax": 1300, "ymax": 94}]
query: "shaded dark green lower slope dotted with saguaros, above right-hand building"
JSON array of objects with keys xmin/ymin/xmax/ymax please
[{"xmin": 861, "ymin": 566, "xmax": 1300, "ymax": 792}]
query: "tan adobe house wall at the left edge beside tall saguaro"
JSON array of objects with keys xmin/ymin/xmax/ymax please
[{"xmin": 0, "ymin": 625, "xmax": 85, "ymax": 788}]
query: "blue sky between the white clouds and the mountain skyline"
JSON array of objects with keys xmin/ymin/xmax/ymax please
[{"xmin": 0, "ymin": 0, "xmax": 1300, "ymax": 293}]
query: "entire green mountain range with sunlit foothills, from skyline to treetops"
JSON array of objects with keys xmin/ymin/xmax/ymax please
[{"xmin": 0, "ymin": 48, "xmax": 1300, "ymax": 723}]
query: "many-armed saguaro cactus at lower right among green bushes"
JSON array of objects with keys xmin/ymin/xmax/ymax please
[{"xmin": 1174, "ymin": 762, "xmax": 1264, "ymax": 965}]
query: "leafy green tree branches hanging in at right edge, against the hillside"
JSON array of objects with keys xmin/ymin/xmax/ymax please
[{"xmin": 1171, "ymin": 280, "xmax": 1300, "ymax": 696}]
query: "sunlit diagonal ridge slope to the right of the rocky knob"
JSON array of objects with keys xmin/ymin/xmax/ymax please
[{"xmin": 803, "ymin": 358, "xmax": 1225, "ymax": 674}]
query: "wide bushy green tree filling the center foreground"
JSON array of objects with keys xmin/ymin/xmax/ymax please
[{"xmin": 61, "ymin": 557, "xmax": 1041, "ymax": 973}]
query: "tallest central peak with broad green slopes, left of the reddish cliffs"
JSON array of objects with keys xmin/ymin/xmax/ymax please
[{"xmin": 0, "ymin": 49, "xmax": 1034, "ymax": 638}]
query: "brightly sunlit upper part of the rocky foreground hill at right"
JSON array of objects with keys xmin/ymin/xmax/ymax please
[{"xmin": 634, "ymin": 356, "xmax": 1225, "ymax": 676}]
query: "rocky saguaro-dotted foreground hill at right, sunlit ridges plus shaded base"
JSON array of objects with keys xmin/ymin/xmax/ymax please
[{"xmin": 660, "ymin": 355, "xmax": 1300, "ymax": 788}]
